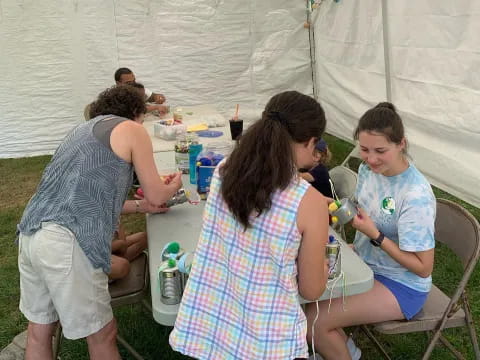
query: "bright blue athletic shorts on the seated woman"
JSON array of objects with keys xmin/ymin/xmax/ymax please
[{"xmin": 374, "ymin": 274, "xmax": 428, "ymax": 320}]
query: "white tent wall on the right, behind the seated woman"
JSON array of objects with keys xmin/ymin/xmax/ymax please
[{"xmin": 314, "ymin": 0, "xmax": 480, "ymax": 207}]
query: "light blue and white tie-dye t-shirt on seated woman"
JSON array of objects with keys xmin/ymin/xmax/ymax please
[{"xmin": 354, "ymin": 164, "xmax": 436, "ymax": 292}]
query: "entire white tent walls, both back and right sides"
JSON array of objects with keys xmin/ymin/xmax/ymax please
[{"xmin": 0, "ymin": 0, "xmax": 480, "ymax": 206}]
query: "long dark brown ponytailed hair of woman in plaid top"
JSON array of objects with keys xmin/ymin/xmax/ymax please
[{"xmin": 220, "ymin": 91, "xmax": 326, "ymax": 229}]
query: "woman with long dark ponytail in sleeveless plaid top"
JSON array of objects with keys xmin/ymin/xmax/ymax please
[{"xmin": 170, "ymin": 91, "xmax": 328, "ymax": 360}]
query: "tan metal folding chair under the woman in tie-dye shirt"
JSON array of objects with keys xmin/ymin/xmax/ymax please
[{"xmin": 361, "ymin": 199, "xmax": 480, "ymax": 360}]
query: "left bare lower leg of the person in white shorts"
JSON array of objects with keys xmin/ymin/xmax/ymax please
[{"xmin": 25, "ymin": 321, "xmax": 57, "ymax": 360}]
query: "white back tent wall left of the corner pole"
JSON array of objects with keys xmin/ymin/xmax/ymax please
[{"xmin": 0, "ymin": 0, "xmax": 313, "ymax": 158}]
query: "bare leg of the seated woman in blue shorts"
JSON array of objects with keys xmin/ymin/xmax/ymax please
[{"xmin": 305, "ymin": 280, "xmax": 404, "ymax": 360}]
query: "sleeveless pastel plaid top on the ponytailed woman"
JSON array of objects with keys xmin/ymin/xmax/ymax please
[{"xmin": 170, "ymin": 168, "xmax": 310, "ymax": 359}]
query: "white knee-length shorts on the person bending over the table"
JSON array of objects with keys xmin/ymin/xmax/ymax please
[{"xmin": 18, "ymin": 222, "xmax": 113, "ymax": 339}]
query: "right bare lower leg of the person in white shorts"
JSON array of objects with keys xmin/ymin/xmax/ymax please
[{"xmin": 87, "ymin": 319, "xmax": 121, "ymax": 360}]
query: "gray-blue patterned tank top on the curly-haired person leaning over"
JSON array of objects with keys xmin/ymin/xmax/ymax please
[{"xmin": 18, "ymin": 115, "xmax": 133, "ymax": 274}]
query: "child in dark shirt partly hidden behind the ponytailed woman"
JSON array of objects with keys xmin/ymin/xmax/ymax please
[{"xmin": 300, "ymin": 139, "xmax": 333, "ymax": 198}]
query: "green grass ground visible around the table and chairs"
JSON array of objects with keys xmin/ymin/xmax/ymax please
[{"xmin": 0, "ymin": 135, "xmax": 480, "ymax": 360}]
